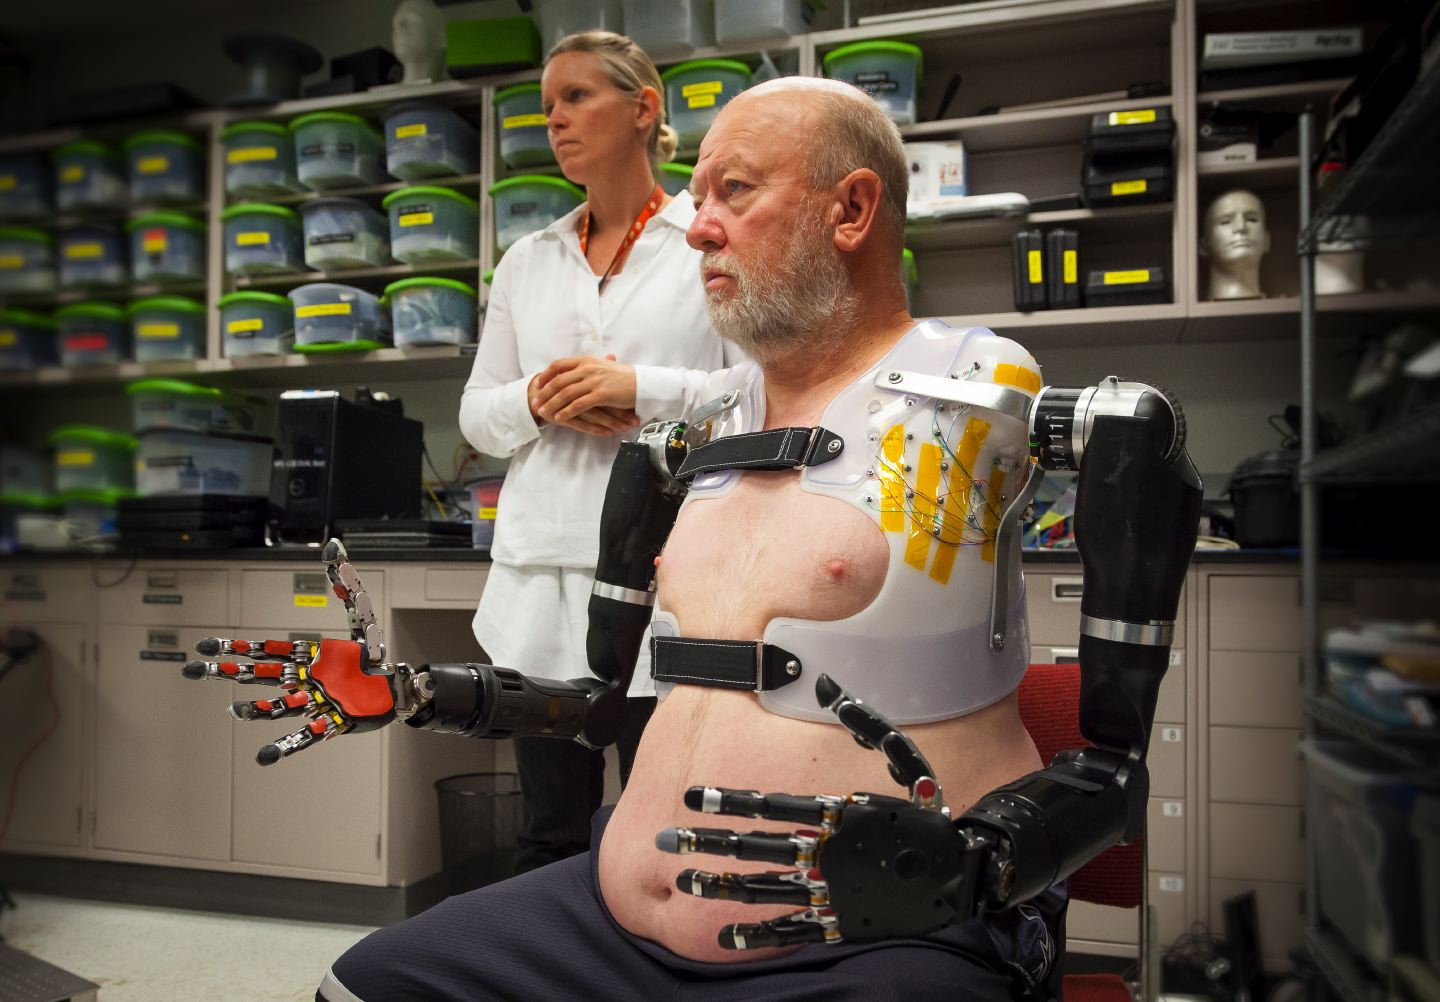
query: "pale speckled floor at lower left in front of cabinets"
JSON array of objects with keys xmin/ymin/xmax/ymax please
[{"xmin": 0, "ymin": 891, "xmax": 373, "ymax": 1002}]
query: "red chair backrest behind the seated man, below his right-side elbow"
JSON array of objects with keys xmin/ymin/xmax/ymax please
[{"xmin": 1020, "ymin": 665, "xmax": 1145, "ymax": 908}]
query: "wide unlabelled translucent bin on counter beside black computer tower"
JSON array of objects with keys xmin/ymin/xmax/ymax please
[{"xmin": 135, "ymin": 428, "xmax": 274, "ymax": 498}]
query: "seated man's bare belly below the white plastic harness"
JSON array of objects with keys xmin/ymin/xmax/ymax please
[{"xmin": 599, "ymin": 685, "xmax": 1040, "ymax": 963}]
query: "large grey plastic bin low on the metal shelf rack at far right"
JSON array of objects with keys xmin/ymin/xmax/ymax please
[{"xmin": 1300, "ymin": 740, "xmax": 1424, "ymax": 970}]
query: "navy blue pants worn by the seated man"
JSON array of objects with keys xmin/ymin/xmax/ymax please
[{"xmin": 326, "ymin": 808, "xmax": 1066, "ymax": 1002}]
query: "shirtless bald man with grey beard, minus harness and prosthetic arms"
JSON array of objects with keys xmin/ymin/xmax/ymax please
[{"xmin": 317, "ymin": 78, "xmax": 1064, "ymax": 1002}]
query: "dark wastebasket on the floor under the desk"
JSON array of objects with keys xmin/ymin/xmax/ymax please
[{"xmin": 435, "ymin": 773, "xmax": 524, "ymax": 894}]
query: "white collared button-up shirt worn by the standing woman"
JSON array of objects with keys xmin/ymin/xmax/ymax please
[{"xmin": 459, "ymin": 196, "xmax": 744, "ymax": 567}]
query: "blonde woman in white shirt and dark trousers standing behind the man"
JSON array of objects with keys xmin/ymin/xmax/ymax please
[{"xmin": 459, "ymin": 32, "xmax": 742, "ymax": 872}]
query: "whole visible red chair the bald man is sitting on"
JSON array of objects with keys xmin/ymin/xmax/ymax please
[{"xmin": 1020, "ymin": 665, "xmax": 1149, "ymax": 1002}]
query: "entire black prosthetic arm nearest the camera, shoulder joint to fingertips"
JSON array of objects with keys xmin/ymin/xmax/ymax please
[{"xmin": 655, "ymin": 377, "xmax": 1201, "ymax": 949}]
